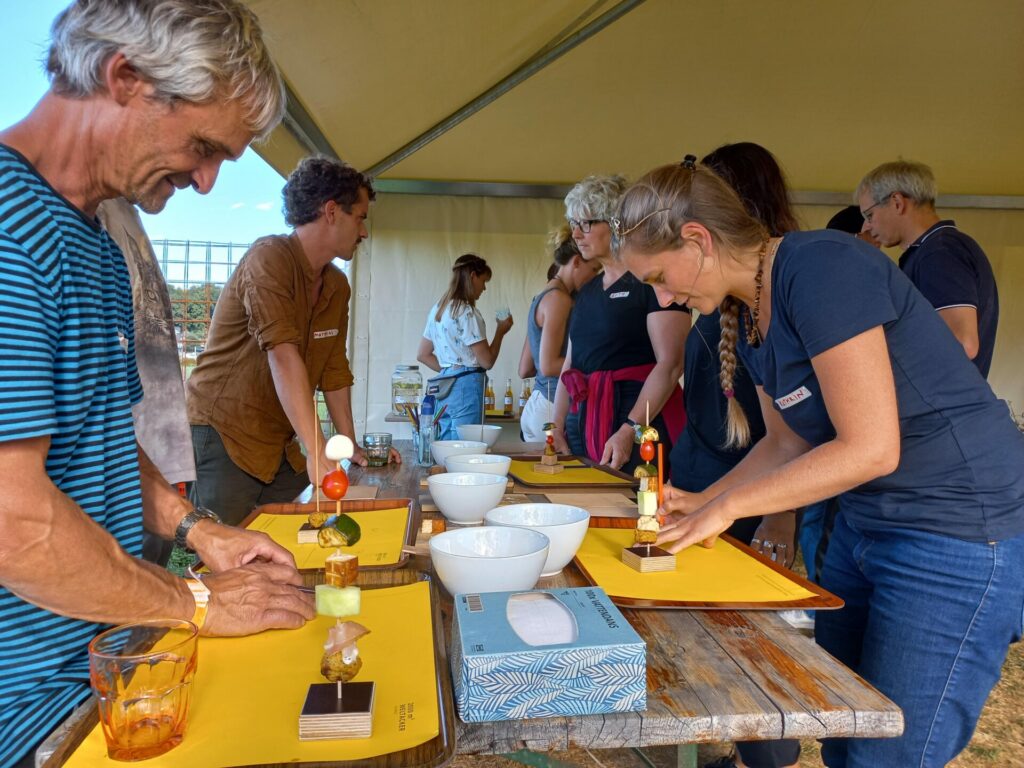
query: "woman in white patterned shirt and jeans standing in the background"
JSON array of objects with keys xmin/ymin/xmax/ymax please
[{"xmin": 416, "ymin": 253, "xmax": 512, "ymax": 440}]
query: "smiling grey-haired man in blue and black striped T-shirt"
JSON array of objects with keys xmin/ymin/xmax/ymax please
[{"xmin": 0, "ymin": 0, "xmax": 314, "ymax": 768}]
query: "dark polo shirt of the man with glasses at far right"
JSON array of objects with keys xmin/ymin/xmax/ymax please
[{"xmin": 899, "ymin": 219, "xmax": 999, "ymax": 378}]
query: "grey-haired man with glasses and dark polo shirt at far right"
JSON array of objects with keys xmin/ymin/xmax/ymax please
[{"xmin": 854, "ymin": 160, "xmax": 999, "ymax": 378}]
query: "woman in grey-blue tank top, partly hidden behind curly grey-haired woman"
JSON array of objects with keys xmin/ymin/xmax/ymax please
[{"xmin": 519, "ymin": 224, "xmax": 600, "ymax": 442}]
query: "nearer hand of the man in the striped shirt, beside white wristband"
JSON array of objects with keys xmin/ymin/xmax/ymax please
[{"xmin": 202, "ymin": 562, "xmax": 316, "ymax": 637}]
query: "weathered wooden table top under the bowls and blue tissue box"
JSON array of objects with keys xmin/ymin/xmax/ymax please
[{"xmin": 350, "ymin": 441, "xmax": 903, "ymax": 754}]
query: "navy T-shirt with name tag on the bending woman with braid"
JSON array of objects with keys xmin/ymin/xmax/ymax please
[{"xmin": 737, "ymin": 231, "xmax": 1024, "ymax": 542}]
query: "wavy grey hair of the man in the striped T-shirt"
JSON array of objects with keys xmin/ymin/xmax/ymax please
[{"xmin": 46, "ymin": 0, "xmax": 285, "ymax": 138}]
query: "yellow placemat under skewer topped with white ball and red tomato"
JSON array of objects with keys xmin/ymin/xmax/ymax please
[{"xmin": 249, "ymin": 504, "xmax": 409, "ymax": 569}]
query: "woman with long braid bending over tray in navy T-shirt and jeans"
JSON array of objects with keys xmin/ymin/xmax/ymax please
[{"xmin": 620, "ymin": 163, "xmax": 1024, "ymax": 768}]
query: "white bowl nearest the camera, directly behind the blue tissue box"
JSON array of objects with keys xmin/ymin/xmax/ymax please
[{"xmin": 430, "ymin": 526, "xmax": 548, "ymax": 596}]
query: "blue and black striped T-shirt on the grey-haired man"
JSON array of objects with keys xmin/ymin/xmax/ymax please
[{"xmin": 0, "ymin": 145, "xmax": 142, "ymax": 767}]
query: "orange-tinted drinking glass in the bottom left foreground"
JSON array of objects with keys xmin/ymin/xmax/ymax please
[{"xmin": 89, "ymin": 620, "xmax": 199, "ymax": 761}]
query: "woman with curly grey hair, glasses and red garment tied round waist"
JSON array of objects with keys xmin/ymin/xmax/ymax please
[{"xmin": 553, "ymin": 176, "xmax": 690, "ymax": 471}]
